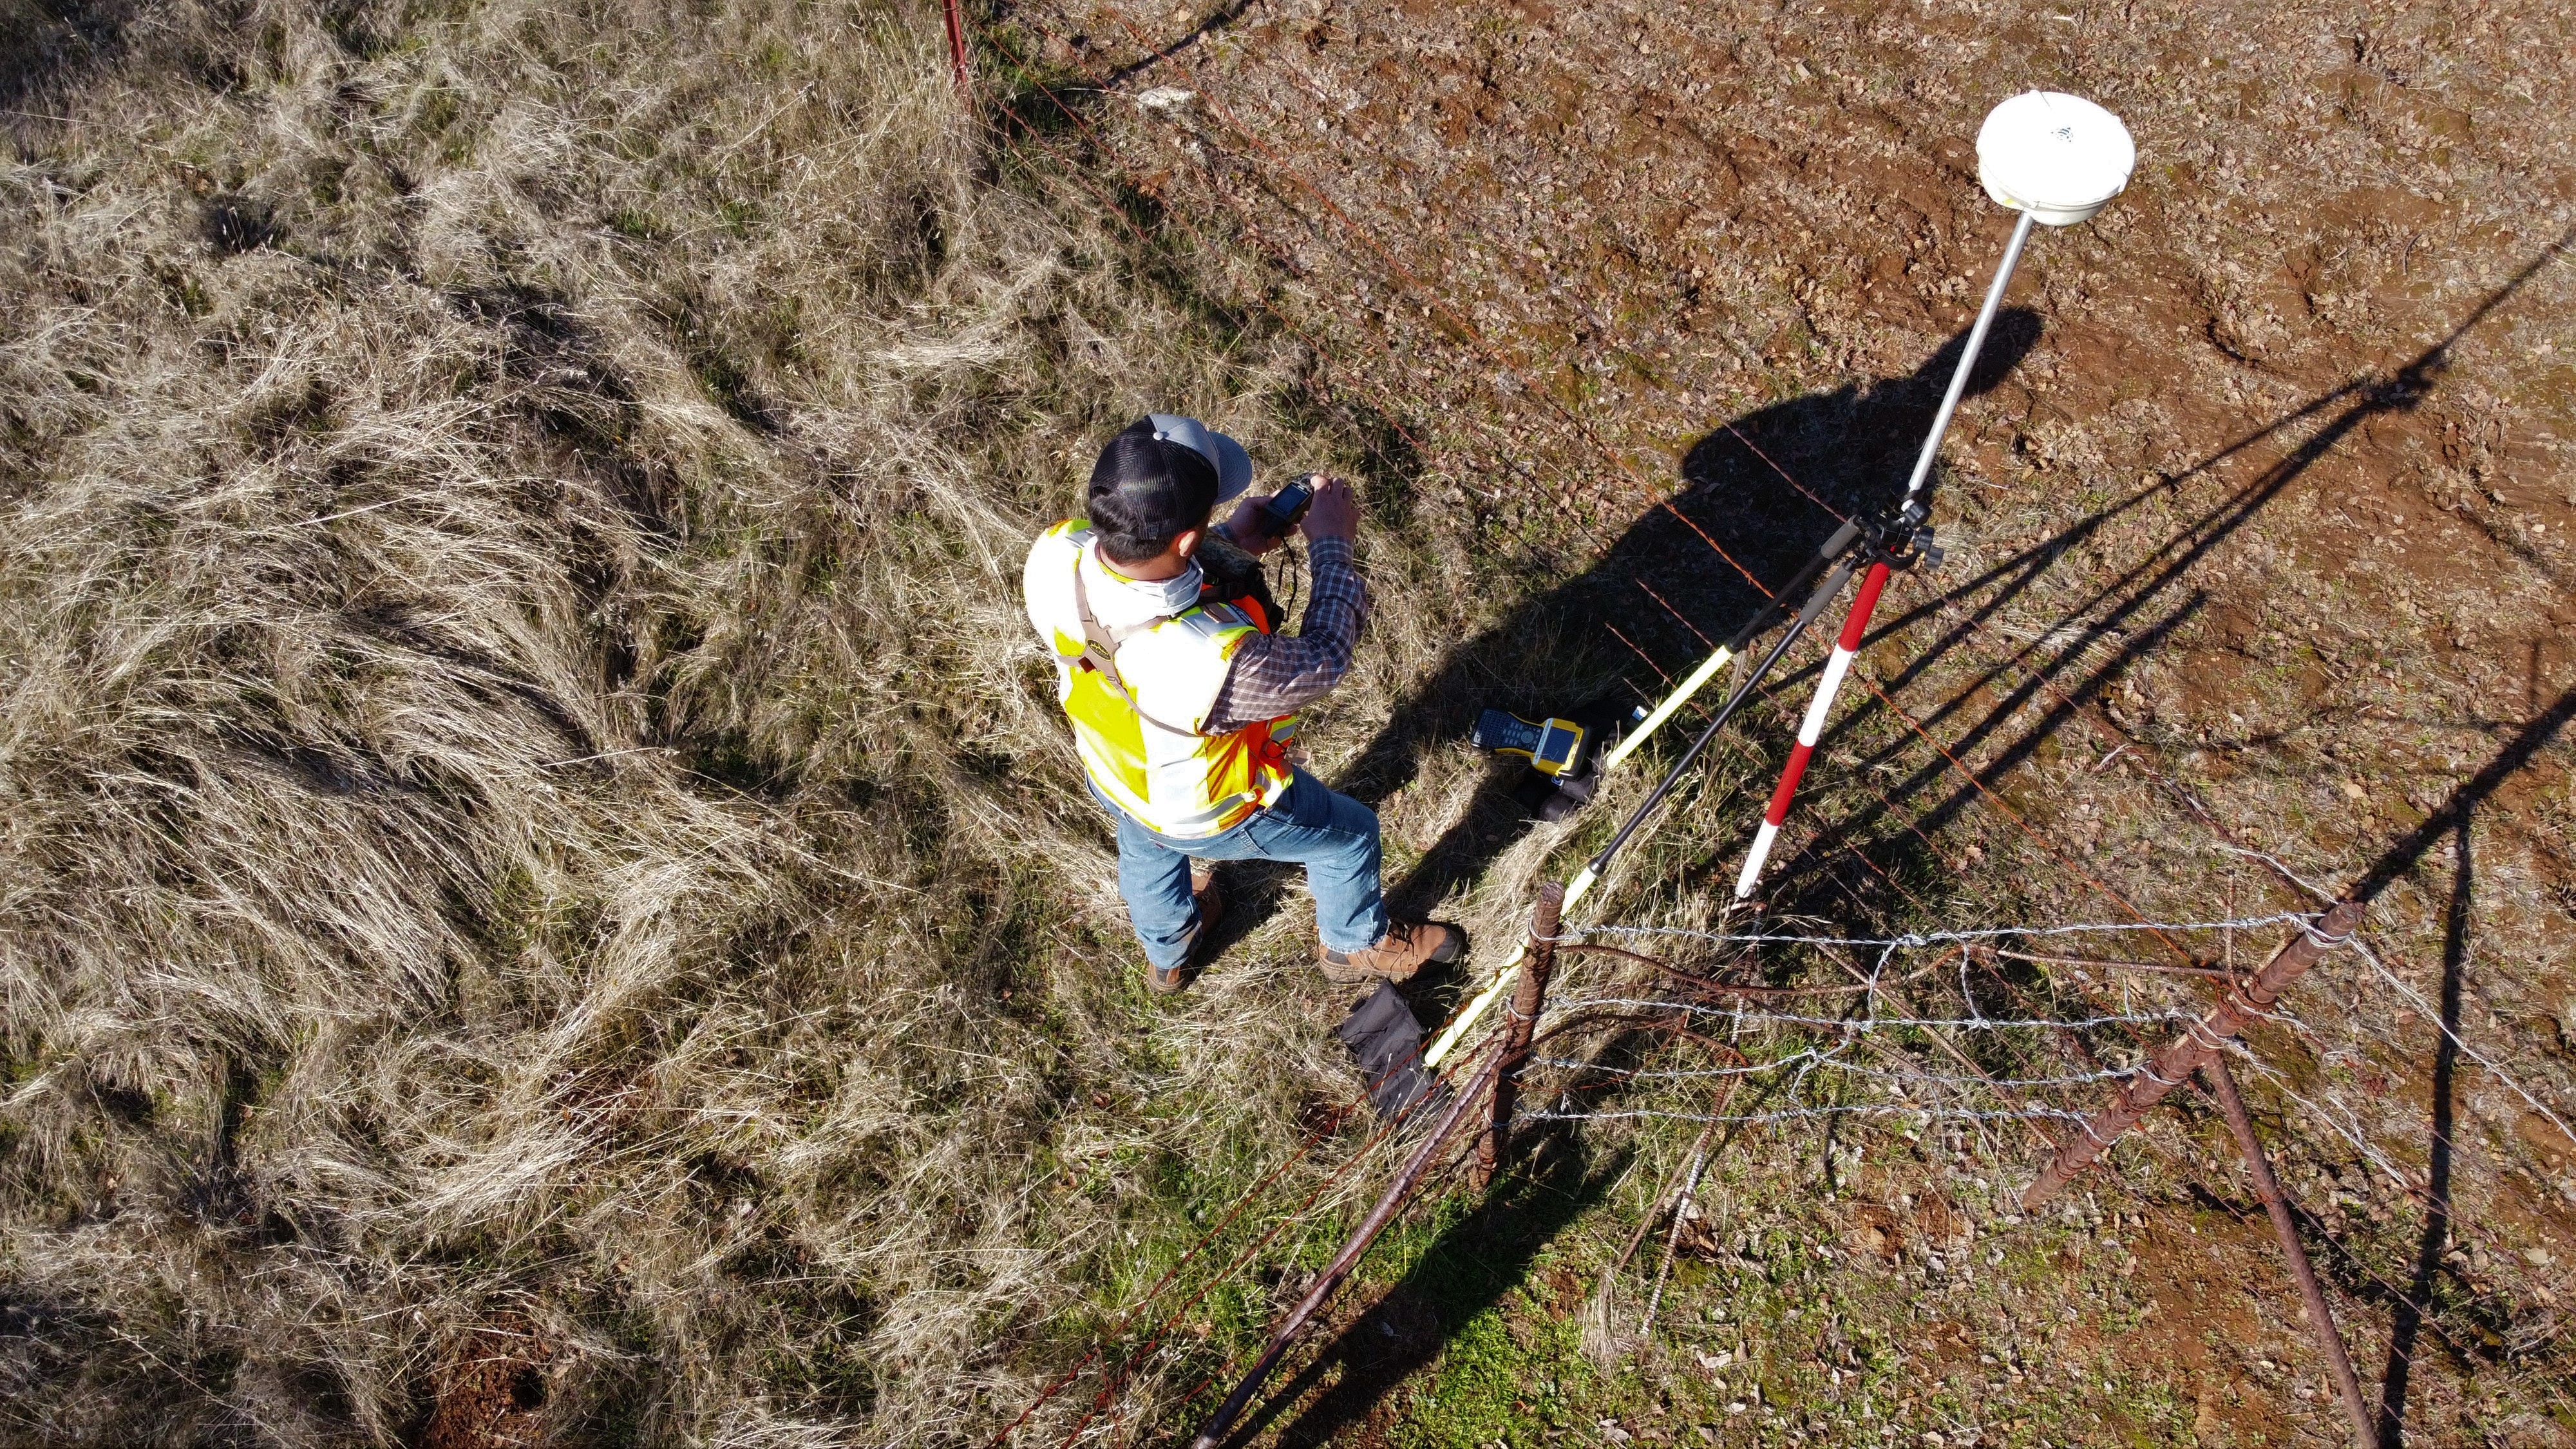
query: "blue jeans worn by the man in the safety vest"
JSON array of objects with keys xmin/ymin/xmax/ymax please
[{"xmin": 1084, "ymin": 771, "xmax": 1386, "ymax": 972}]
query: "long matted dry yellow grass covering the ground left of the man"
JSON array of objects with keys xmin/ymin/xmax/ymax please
[{"xmin": 0, "ymin": 0, "xmax": 1412, "ymax": 1444}]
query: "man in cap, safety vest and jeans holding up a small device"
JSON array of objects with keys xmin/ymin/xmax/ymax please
[{"xmin": 1020, "ymin": 413, "xmax": 1466, "ymax": 992}]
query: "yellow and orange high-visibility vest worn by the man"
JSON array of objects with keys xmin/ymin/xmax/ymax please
[{"xmin": 1020, "ymin": 518, "xmax": 1296, "ymax": 840}]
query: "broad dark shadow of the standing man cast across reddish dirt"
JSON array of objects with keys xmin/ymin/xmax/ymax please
[{"xmin": 1337, "ymin": 307, "xmax": 2040, "ymax": 918}]
